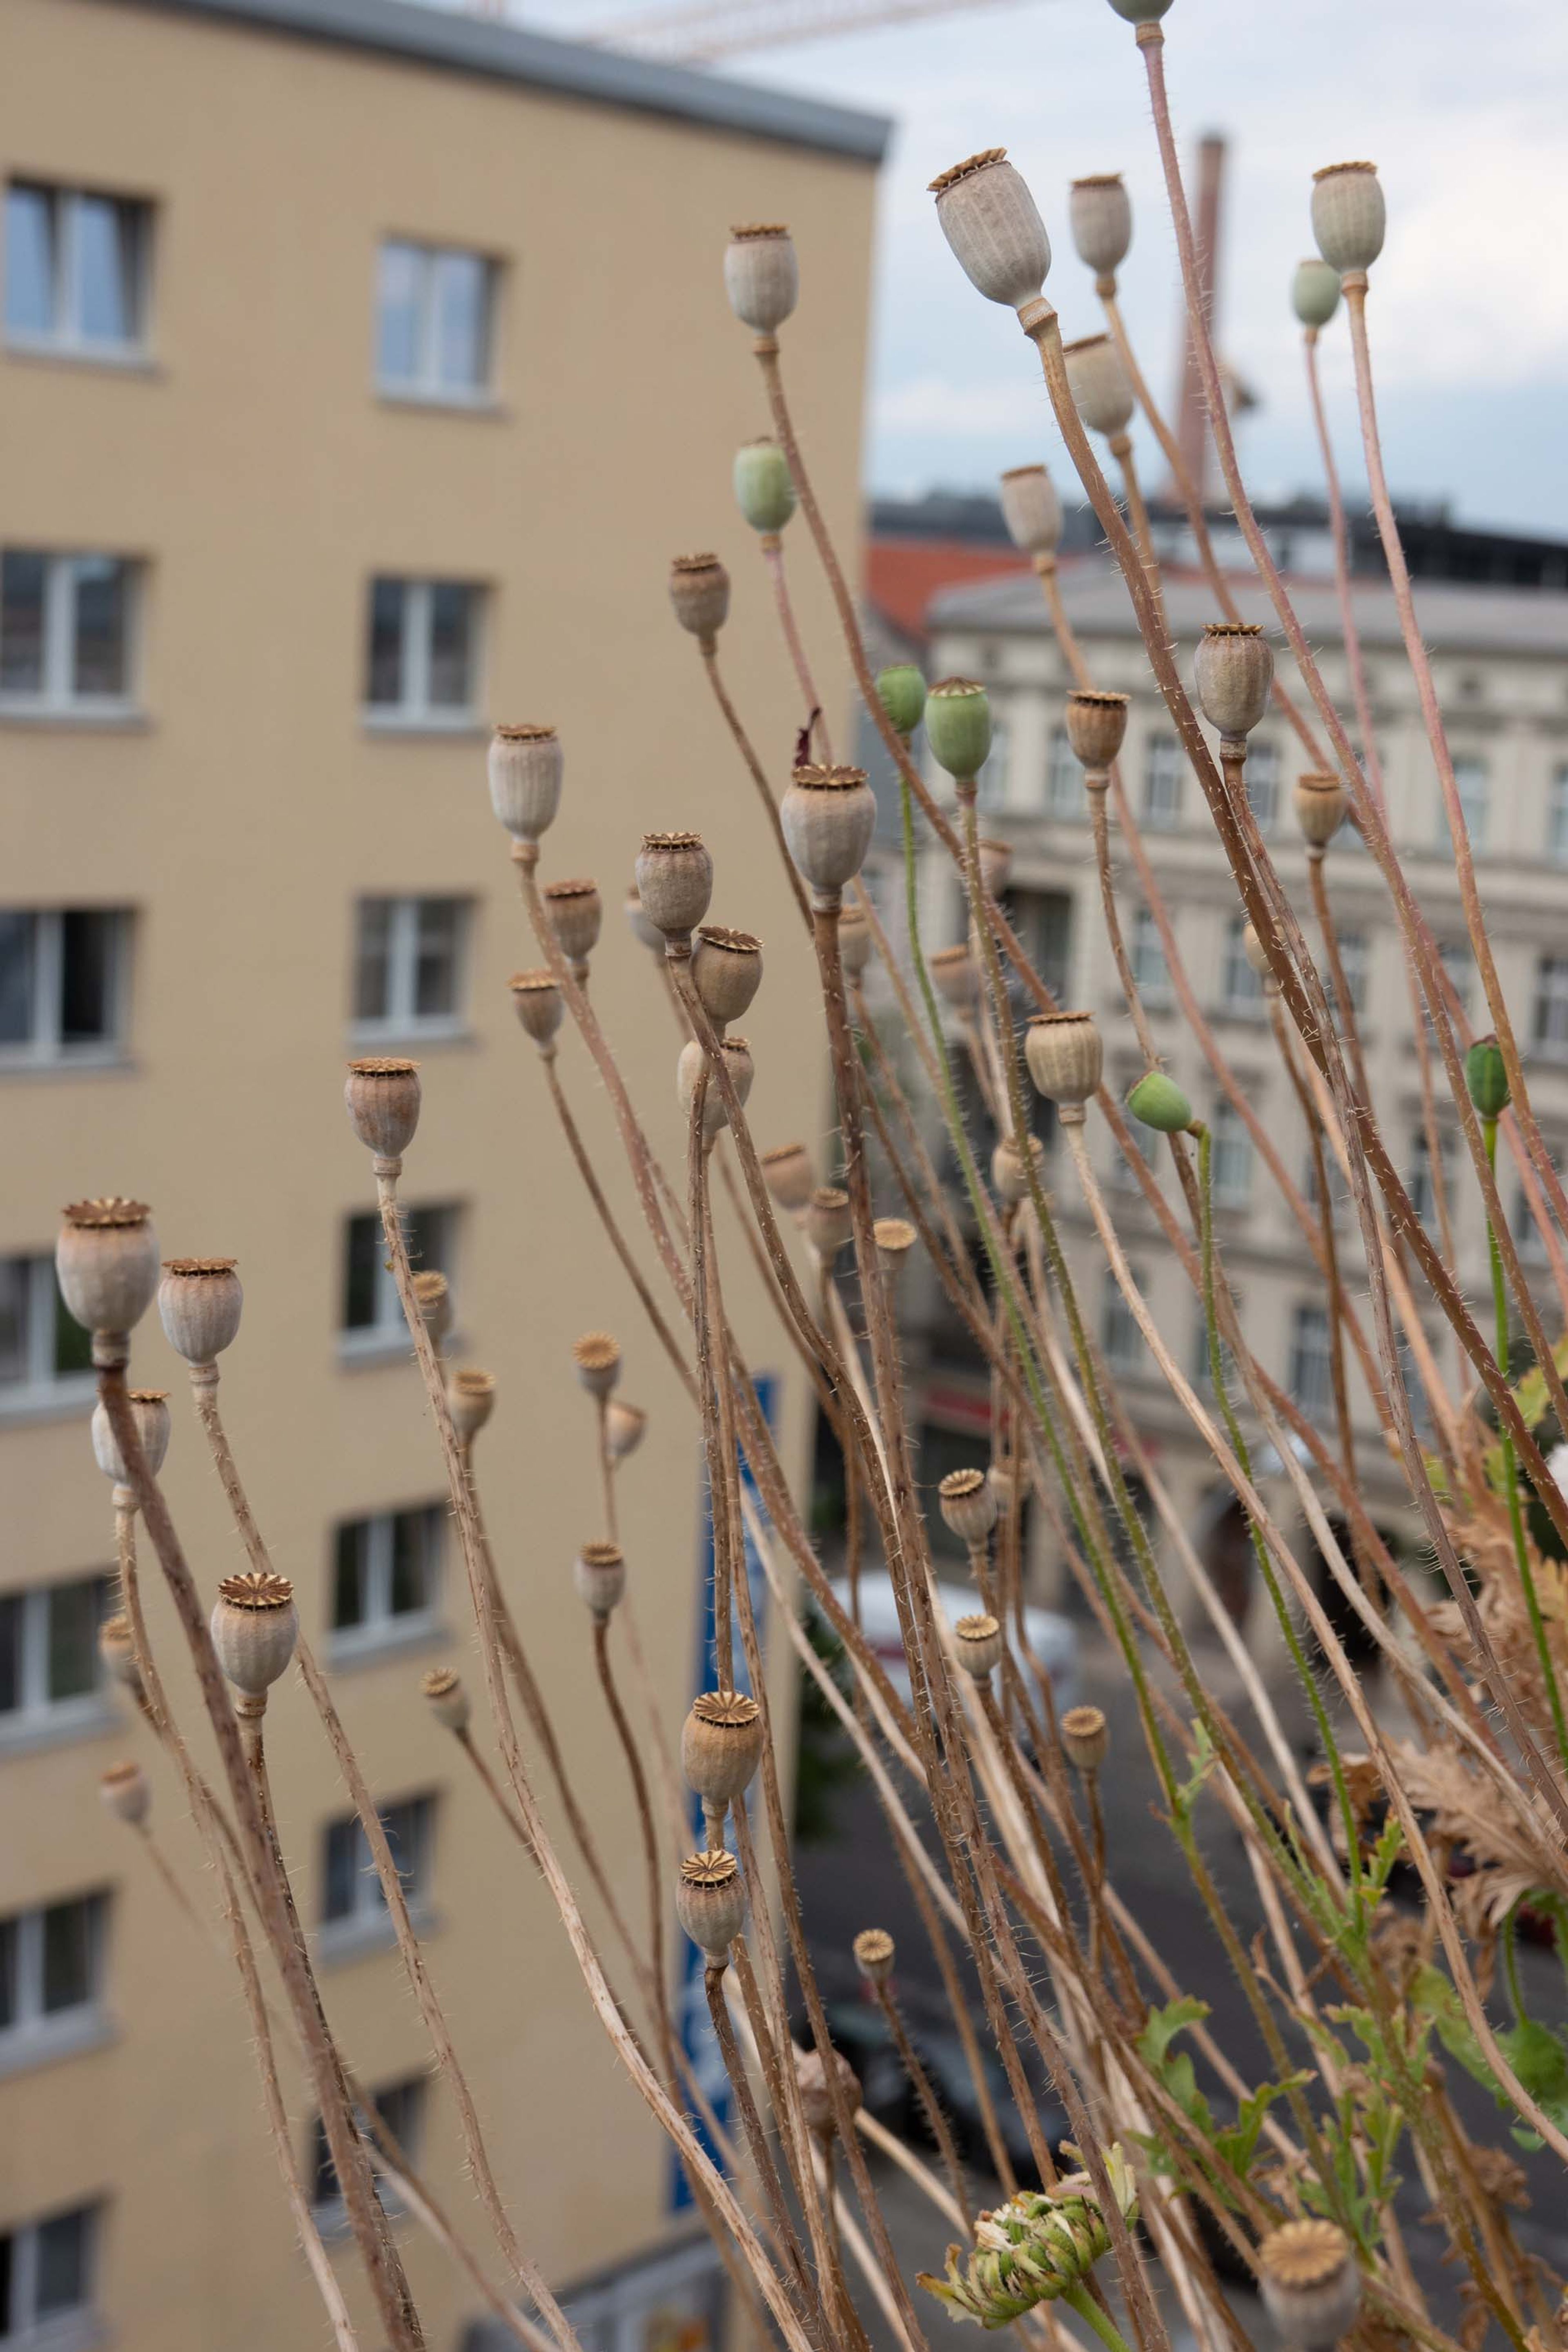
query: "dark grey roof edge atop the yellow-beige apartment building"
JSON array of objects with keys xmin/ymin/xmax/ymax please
[{"xmin": 95, "ymin": 0, "xmax": 893, "ymax": 162}]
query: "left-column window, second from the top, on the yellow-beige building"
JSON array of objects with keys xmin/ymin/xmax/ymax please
[{"xmin": 0, "ymin": 548, "xmax": 136, "ymax": 717}]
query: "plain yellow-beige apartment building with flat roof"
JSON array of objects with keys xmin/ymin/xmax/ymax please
[{"xmin": 0, "ymin": 0, "xmax": 886, "ymax": 2352}]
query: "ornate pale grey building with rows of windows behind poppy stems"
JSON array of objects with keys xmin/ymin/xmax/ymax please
[{"xmin": 924, "ymin": 550, "xmax": 1568, "ymax": 1646}]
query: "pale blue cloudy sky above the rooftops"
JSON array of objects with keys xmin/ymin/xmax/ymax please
[{"xmin": 510, "ymin": 0, "xmax": 1568, "ymax": 534}]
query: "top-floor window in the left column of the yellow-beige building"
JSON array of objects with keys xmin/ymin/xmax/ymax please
[{"xmin": 5, "ymin": 179, "xmax": 153, "ymax": 360}]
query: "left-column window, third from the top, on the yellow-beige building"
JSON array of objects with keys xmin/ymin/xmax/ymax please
[{"xmin": 0, "ymin": 908, "xmax": 129, "ymax": 1068}]
